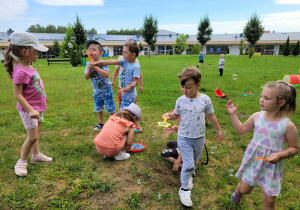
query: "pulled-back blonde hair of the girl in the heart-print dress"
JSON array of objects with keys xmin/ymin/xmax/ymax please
[{"xmin": 263, "ymin": 81, "xmax": 297, "ymax": 116}]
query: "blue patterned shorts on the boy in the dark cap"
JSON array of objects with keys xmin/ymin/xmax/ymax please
[{"xmin": 93, "ymin": 88, "xmax": 116, "ymax": 113}]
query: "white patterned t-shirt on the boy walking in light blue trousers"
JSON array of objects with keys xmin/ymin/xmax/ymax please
[{"xmin": 174, "ymin": 94, "xmax": 214, "ymax": 138}]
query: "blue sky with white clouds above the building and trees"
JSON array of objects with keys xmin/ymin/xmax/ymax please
[{"xmin": 0, "ymin": 0, "xmax": 300, "ymax": 35}]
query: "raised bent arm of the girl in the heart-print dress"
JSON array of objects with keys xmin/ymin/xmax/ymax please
[{"xmin": 226, "ymin": 100, "xmax": 259, "ymax": 135}]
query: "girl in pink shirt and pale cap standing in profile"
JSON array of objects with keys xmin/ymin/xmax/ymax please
[{"xmin": 4, "ymin": 32, "xmax": 53, "ymax": 176}]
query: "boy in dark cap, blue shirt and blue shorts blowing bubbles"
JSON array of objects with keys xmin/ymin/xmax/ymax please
[{"xmin": 84, "ymin": 40, "xmax": 116, "ymax": 130}]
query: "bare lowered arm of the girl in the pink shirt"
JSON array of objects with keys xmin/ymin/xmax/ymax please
[{"xmin": 14, "ymin": 84, "xmax": 40, "ymax": 118}]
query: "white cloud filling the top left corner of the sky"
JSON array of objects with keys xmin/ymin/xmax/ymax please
[{"xmin": 0, "ymin": 0, "xmax": 28, "ymax": 22}]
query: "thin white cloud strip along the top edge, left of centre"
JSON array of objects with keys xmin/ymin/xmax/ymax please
[{"xmin": 34, "ymin": 0, "xmax": 104, "ymax": 6}]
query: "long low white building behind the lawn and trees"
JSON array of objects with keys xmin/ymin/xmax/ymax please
[{"xmin": 0, "ymin": 29, "xmax": 300, "ymax": 60}]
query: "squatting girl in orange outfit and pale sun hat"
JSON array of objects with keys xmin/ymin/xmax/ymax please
[{"xmin": 94, "ymin": 103, "xmax": 141, "ymax": 160}]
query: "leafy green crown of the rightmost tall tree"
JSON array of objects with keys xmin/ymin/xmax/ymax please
[{"xmin": 243, "ymin": 13, "xmax": 265, "ymax": 48}]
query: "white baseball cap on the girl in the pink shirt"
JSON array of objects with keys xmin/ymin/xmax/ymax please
[{"xmin": 9, "ymin": 32, "xmax": 49, "ymax": 52}]
